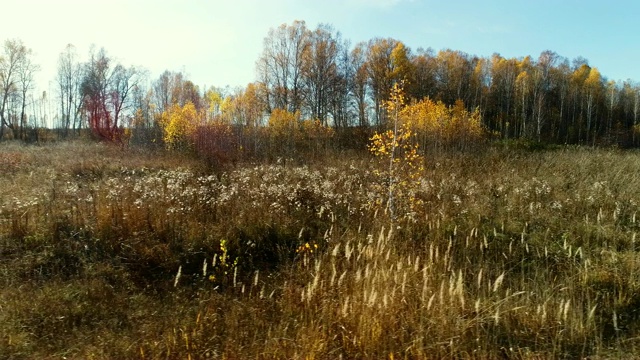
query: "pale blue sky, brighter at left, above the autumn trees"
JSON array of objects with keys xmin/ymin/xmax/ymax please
[{"xmin": 0, "ymin": 0, "xmax": 640, "ymax": 95}]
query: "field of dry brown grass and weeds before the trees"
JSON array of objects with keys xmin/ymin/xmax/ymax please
[{"xmin": 0, "ymin": 143, "xmax": 640, "ymax": 359}]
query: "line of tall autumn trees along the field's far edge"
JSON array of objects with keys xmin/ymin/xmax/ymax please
[{"xmin": 0, "ymin": 21, "xmax": 640, "ymax": 147}]
